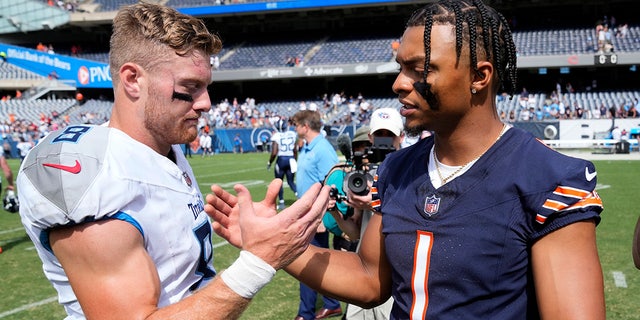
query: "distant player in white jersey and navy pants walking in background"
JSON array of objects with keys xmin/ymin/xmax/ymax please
[{"xmin": 267, "ymin": 119, "xmax": 298, "ymax": 210}]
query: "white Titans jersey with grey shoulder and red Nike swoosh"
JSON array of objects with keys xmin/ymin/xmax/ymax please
[{"xmin": 17, "ymin": 125, "xmax": 215, "ymax": 319}]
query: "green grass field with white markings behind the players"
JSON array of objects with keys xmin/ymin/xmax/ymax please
[{"xmin": 0, "ymin": 153, "xmax": 640, "ymax": 320}]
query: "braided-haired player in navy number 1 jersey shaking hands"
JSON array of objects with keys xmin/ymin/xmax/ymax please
[{"xmin": 209, "ymin": 0, "xmax": 605, "ymax": 319}]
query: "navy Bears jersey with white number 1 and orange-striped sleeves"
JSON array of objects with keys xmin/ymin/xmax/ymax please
[{"xmin": 372, "ymin": 128, "xmax": 602, "ymax": 319}]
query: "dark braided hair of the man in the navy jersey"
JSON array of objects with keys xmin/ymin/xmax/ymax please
[{"xmin": 406, "ymin": 0, "xmax": 517, "ymax": 95}]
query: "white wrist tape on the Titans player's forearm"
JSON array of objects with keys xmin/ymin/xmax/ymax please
[{"xmin": 220, "ymin": 250, "xmax": 276, "ymax": 299}]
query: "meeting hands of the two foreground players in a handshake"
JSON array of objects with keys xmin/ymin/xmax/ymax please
[{"xmin": 205, "ymin": 179, "xmax": 330, "ymax": 270}]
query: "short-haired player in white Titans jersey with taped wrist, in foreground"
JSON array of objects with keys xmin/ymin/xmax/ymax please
[{"xmin": 17, "ymin": 3, "xmax": 328, "ymax": 319}]
